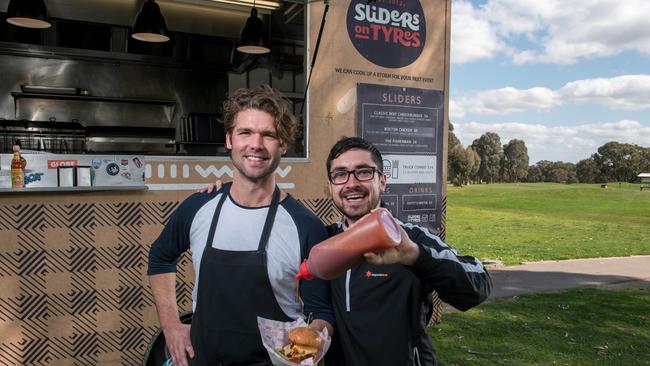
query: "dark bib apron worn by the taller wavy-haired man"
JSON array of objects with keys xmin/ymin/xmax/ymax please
[{"xmin": 190, "ymin": 183, "xmax": 292, "ymax": 366}]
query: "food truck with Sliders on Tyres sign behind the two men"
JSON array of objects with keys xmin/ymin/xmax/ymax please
[{"xmin": 0, "ymin": 0, "xmax": 451, "ymax": 365}]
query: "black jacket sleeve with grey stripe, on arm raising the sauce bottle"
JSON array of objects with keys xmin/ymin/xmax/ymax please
[{"xmin": 403, "ymin": 224, "xmax": 492, "ymax": 311}]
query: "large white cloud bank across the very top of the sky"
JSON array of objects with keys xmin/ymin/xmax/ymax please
[{"xmin": 451, "ymin": 0, "xmax": 650, "ymax": 64}]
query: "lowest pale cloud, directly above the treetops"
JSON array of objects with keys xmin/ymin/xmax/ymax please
[{"xmin": 454, "ymin": 120, "xmax": 650, "ymax": 164}]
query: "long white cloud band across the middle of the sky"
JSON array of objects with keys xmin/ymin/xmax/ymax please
[{"xmin": 449, "ymin": 75, "xmax": 650, "ymax": 118}]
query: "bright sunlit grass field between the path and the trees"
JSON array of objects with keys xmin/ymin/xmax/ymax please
[{"xmin": 446, "ymin": 183, "xmax": 650, "ymax": 264}]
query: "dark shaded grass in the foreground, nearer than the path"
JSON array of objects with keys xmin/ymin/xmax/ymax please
[{"xmin": 428, "ymin": 288, "xmax": 650, "ymax": 366}]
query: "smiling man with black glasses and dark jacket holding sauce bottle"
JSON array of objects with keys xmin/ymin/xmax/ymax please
[{"xmin": 325, "ymin": 137, "xmax": 492, "ymax": 366}]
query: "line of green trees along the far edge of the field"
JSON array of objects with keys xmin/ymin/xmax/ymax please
[{"xmin": 447, "ymin": 123, "xmax": 650, "ymax": 186}]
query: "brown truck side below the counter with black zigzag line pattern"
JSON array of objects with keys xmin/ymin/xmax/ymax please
[{"xmin": 0, "ymin": 198, "xmax": 340, "ymax": 366}]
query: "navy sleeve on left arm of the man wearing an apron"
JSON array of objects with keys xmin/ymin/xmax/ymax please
[{"xmin": 147, "ymin": 192, "xmax": 217, "ymax": 275}]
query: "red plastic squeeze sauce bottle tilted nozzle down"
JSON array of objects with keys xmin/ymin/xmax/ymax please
[{"xmin": 296, "ymin": 208, "xmax": 402, "ymax": 280}]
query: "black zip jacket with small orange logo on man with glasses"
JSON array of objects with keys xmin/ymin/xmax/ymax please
[{"xmin": 325, "ymin": 222, "xmax": 492, "ymax": 366}]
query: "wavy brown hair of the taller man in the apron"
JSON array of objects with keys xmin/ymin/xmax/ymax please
[{"xmin": 223, "ymin": 85, "xmax": 298, "ymax": 146}]
